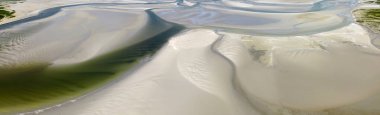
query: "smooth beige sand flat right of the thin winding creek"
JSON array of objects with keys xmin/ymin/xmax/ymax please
[{"xmin": 221, "ymin": 24, "xmax": 380, "ymax": 111}]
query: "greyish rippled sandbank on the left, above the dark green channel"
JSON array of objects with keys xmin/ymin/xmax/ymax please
[{"xmin": 0, "ymin": 6, "xmax": 171, "ymax": 72}]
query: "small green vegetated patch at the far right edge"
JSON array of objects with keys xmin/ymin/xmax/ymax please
[{"xmin": 353, "ymin": 9, "xmax": 380, "ymax": 33}]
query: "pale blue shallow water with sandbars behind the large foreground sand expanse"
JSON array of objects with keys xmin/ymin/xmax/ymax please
[{"xmin": 153, "ymin": 0, "xmax": 357, "ymax": 35}]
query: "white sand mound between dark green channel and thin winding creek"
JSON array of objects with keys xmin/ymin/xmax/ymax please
[{"xmin": 36, "ymin": 30, "xmax": 255, "ymax": 115}]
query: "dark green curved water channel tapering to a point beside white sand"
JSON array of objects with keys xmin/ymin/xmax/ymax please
[{"xmin": 0, "ymin": 26, "xmax": 182, "ymax": 114}]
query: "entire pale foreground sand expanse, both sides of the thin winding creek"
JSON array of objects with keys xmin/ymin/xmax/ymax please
[{"xmin": 36, "ymin": 24, "xmax": 380, "ymax": 115}]
